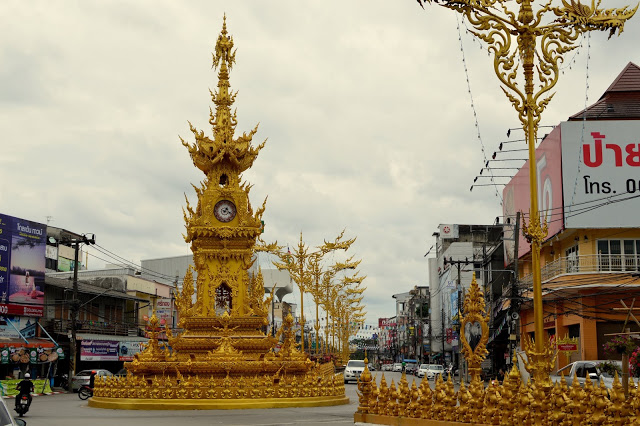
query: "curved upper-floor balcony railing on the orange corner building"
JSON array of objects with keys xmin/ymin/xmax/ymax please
[{"xmin": 520, "ymin": 254, "xmax": 640, "ymax": 287}]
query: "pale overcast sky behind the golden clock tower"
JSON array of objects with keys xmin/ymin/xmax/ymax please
[{"xmin": 0, "ymin": 0, "xmax": 640, "ymax": 323}]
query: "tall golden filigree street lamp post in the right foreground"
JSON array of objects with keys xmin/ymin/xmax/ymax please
[{"xmin": 418, "ymin": 0, "xmax": 638, "ymax": 383}]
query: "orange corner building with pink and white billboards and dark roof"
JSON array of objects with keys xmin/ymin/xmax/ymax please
[{"xmin": 504, "ymin": 63, "xmax": 640, "ymax": 367}]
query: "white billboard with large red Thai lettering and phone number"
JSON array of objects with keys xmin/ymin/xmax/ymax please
[{"xmin": 561, "ymin": 120, "xmax": 640, "ymax": 228}]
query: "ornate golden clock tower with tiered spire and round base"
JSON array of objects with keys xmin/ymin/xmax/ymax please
[{"xmin": 89, "ymin": 17, "xmax": 349, "ymax": 410}]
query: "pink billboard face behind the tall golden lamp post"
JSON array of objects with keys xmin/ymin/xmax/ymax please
[{"xmin": 502, "ymin": 126, "xmax": 563, "ymax": 265}]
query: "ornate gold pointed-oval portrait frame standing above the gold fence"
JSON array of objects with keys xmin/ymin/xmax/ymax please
[{"xmin": 458, "ymin": 272, "xmax": 489, "ymax": 382}]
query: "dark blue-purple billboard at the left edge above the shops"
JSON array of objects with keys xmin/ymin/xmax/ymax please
[{"xmin": 0, "ymin": 214, "xmax": 47, "ymax": 316}]
